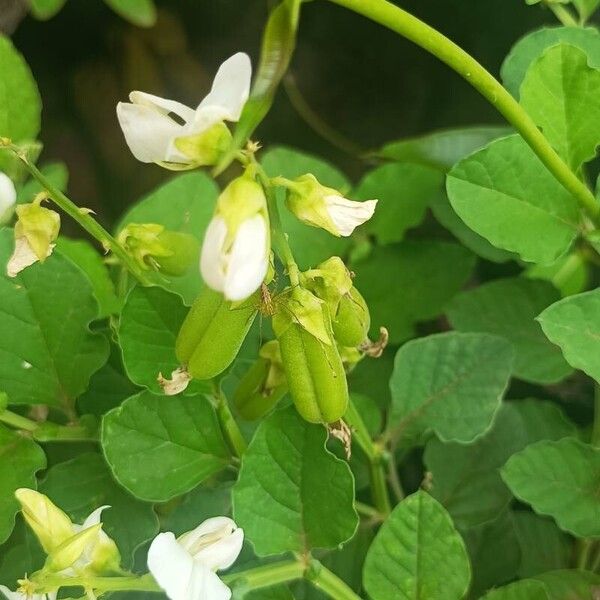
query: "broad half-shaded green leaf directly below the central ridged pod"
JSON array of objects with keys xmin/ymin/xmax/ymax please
[{"xmin": 233, "ymin": 407, "xmax": 358, "ymax": 556}]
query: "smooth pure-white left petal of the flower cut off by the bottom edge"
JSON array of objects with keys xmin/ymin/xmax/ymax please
[{"xmin": 148, "ymin": 532, "xmax": 231, "ymax": 600}]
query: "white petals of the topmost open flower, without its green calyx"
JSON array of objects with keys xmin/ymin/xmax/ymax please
[{"xmin": 117, "ymin": 52, "xmax": 252, "ymax": 166}]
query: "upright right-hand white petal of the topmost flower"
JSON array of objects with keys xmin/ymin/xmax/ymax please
[{"xmin": 198, "ymin": 52, "xmax": 252, "ymax": 121}]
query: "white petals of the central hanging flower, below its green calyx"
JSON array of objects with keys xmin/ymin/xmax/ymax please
[{"xmin": 200, "ymin": 213, "xmax": 269, "ymax": 302}]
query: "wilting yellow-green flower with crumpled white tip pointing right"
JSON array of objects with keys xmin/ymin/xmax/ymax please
[{"xmin": 283, "ymin": 174, "xmax": 377, "ymax": 237}]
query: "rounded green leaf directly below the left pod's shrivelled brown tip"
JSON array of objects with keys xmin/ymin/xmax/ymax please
[{"xmin": 101, "ymin": 392, "xmax": 229, "ymax": 502}]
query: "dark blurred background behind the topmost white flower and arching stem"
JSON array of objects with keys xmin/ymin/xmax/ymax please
[{"xmin": 0, "ymin": 0, "xmax": 555, "ymax": 225}]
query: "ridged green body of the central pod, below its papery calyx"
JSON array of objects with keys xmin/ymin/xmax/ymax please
[{"xmin": 273, "ymin": 305, "xmax": 348, "ymax": 423}]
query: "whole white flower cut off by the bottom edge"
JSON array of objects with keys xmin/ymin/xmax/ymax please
[{"xmin": 148, "ymin": 517, "xmax": 244, "ymax": 600}]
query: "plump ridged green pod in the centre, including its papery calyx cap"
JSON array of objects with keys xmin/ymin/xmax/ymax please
[{"xmin": 273, "ymin": 288, "xmax": 348, "ymax": 423}]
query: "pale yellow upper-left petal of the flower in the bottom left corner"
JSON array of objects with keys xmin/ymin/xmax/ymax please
[{"xmin": 15, "ymin": 488, "xmax": 73, "ymax": 554}]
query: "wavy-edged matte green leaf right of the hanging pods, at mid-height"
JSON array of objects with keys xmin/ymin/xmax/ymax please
[{"xmin": 388, "ymin": 332, "xmax": 513, "ymax": 443}]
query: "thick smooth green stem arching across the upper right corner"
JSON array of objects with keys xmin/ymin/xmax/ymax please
[{"xmin": 330, "ymin": 0, "xmax": 600, "ymax": 222}]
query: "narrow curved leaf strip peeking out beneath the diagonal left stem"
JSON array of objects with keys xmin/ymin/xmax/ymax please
[{"xmin": 57, "ymin": 236, "xmax": 121, "ymax": 319}]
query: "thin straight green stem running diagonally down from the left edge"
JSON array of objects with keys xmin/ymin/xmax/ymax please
[{"xmin": 8, "ymin": 145, "xmax": 149, "ymax": 285}]
